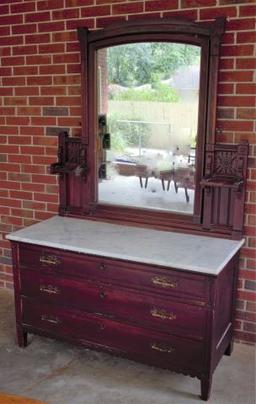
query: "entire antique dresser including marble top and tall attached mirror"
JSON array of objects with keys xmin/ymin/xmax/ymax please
[{"xmin": 7, "ymin": 18, "xmax": 248, "ymax": 400}]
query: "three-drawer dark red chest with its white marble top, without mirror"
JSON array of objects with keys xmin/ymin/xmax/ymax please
[{"xmin": 7, "ymin": 216, "xmax": 243, "ymax": 400}]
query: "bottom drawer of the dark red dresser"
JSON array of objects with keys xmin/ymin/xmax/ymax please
[{"xmin": 22, "ymin": 298, "xmax": 204, "ymax": 370}]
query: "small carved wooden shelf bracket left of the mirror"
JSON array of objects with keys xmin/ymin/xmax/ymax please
[{"xmin": 50, "ymin": 132, "xmax": 88, "ymax": 177}]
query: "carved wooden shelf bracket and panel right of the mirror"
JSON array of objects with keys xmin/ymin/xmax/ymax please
[{"xmin": 200, "ymin": 142, "xmax": 249, "ymax": 238}]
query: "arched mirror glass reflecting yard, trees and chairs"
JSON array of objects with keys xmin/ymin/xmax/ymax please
[{"xmin": 97, "ymin": 42, "xmax": 201, "ymax": 214}]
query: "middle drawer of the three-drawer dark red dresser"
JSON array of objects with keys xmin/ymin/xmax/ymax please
[{"xmin": 21, "ymin": 270, "xmax": 208, "ymax": 340}]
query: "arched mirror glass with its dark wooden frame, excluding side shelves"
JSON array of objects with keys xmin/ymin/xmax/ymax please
[{"xmin": 75, "ymin": 18, "xmax": 224, "ymax": 230}]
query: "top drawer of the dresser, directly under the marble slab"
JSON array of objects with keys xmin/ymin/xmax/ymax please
[{"xmin": 19, "ymin": 244, "xmax": 210, "ymax": 300}]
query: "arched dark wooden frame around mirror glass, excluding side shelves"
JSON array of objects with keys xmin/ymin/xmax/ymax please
[{"xmin": 78, "ymin": 18, "xmax": 224, "ymax": 226}]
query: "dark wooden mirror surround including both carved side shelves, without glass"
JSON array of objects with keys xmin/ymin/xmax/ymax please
[{"xmin": 51, "ymin": 17, "xmax": 248, "ymax": 238}]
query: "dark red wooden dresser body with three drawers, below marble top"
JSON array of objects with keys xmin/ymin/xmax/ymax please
[{"xmin": 13, "ymin": 242, "xmax": 238, "ymax": 400}]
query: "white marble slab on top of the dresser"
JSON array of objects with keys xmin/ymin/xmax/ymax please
[{"xmin": 7, "ymin": 216, "xmax": 244, "ymax": 275}]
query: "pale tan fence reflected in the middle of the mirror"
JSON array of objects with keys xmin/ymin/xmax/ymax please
[{"xmin": 108, "ymin": 100, "xmax": 198, "ymax": 154}]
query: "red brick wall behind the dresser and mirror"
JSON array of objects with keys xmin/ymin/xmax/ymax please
[{"xmin": 0, "ymin": 0, "xmax": 256, "ymax": 342}]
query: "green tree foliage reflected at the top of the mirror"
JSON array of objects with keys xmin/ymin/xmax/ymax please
[{"xmin": 107, "ymin": 42, "xmax": 200, "ymax": 87}]
